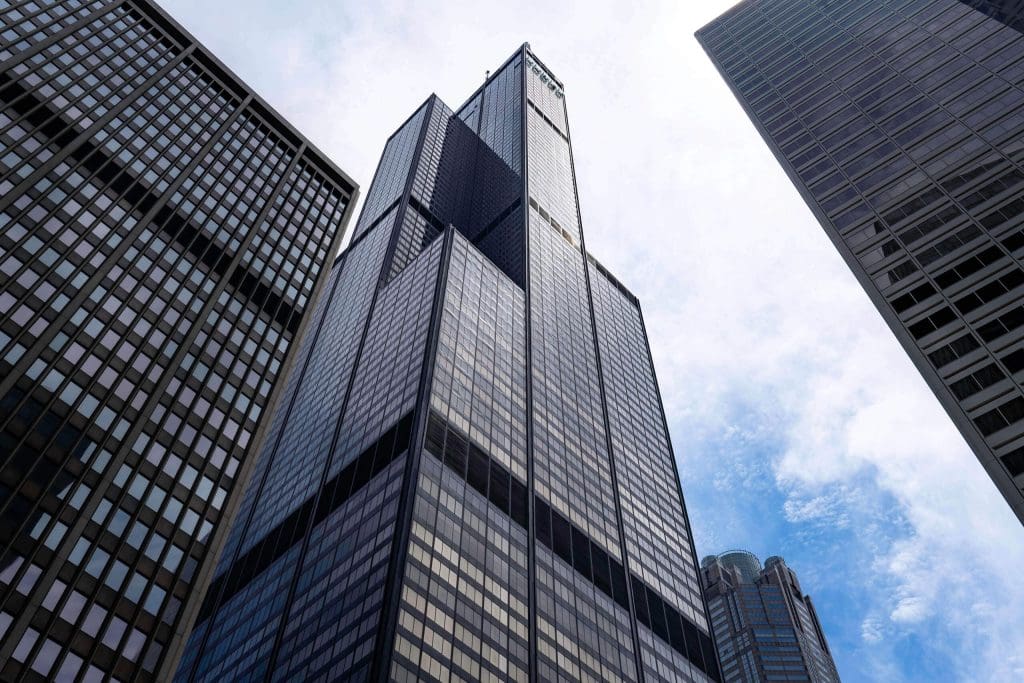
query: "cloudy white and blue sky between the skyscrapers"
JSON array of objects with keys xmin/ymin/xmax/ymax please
[{"xmin": 162, "ymin": 0, "xmax": 1024, "ymax": 683}]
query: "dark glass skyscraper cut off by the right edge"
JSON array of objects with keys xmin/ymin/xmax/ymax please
[{"xmin": 697, "ymin": 0, "xmax": 1024, "ymax": 522}]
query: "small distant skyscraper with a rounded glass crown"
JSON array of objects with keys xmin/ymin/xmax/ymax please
[{"xmin": 700, "ymin": 550, "xmax": 839, "ymax": 683}]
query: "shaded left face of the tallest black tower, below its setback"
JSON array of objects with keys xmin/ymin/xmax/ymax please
[{"xmin": 177, "ymin": 231, "xmax": 443, "ymax": 680}]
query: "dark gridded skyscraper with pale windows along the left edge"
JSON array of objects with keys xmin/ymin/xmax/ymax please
[{"xmin": 0, "ymin": 0, "xmax": 355, "ymax": 681}]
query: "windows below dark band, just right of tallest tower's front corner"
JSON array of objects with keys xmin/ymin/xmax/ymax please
[{"xmin": 390, "ymin": 454, "xmax": 529, "ymax": 682}]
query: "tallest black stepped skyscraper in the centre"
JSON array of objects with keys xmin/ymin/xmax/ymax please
[{"xmin": 176, "ymin": 45, "xmax": 718, "ymax": 681}]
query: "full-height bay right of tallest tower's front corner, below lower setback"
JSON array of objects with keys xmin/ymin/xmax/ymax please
[{"xmin": 391, "ymin": 236, "xmax": 528, "ymax": 681}]
